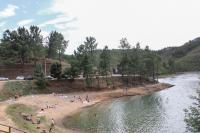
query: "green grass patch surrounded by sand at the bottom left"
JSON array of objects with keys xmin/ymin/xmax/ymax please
[{"xmin": 6, "ymin": 104, "xmax": 39, "ymax": 133}]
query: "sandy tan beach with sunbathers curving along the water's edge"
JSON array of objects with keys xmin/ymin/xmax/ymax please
[{"xmin": 0, "ymin": 83, "xmax": 171, "ymax": 133}]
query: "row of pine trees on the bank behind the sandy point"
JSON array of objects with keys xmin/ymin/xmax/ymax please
[{"xmin": 65, "ymin": 37, "xmax": 161, "ymax": 87}]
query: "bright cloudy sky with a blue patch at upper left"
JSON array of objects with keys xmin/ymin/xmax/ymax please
[{"xmin": 0, "ymin": 0, "xmax": 200, "ymax": 54}]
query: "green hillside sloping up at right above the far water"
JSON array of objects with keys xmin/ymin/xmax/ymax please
[{"xmin": 158, "ymin": 37, "xmax": 200, "ymax": 71}]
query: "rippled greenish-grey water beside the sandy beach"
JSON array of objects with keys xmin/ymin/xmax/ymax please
[{"xmin": 66, "ymin": 73, "xmax": 200, "ymax": 133}]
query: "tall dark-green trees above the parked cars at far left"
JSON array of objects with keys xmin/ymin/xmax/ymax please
[{"xmin": 0, "ymin": 26, "xmax": 68, "ymax": 64}]
